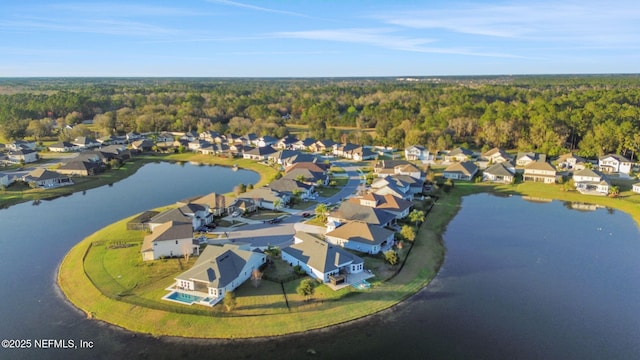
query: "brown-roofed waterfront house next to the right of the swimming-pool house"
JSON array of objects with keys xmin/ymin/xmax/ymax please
[{"xmin": 282, "ymin": 231, "xmax": 364, "ymax": 285}]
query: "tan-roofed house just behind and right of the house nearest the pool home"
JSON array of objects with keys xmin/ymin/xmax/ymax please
[{"xmin": 325, "ymin": 221, "xmax": 394, "ymax": 254}]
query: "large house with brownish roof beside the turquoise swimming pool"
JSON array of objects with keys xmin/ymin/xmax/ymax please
[{"xmin": 168, "ymin": 244, "xmax": 267, "ymax": 306}]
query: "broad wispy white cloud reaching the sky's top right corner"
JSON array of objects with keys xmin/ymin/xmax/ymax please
[{"xmin": 374, "ymin": 0, "xmax": 640, "ymax": 44}]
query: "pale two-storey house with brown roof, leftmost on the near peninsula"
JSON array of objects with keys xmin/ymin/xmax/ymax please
[{"xmin": 140, "ymin": 221, "xmax": 200, "ymax": 261}]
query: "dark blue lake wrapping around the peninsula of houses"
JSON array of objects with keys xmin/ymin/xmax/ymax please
[{"xmin": 0, "ymin": 167, "xmax": 640, "ymax": 359}]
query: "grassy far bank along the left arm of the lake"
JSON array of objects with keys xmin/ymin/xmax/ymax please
[{"xmin": 0, "ymin": 153, "xmax": 276, "ymax": 208}]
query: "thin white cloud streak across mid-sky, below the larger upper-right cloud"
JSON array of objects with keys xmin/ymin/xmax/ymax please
[{"xmin": 273, "ymin": 28, "xmax": 515, "ymax": 57}]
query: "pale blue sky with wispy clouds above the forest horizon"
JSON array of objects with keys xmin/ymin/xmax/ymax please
[{"xmin": 0, "ymin": 0, "xmax": 640, "ymax": 77}]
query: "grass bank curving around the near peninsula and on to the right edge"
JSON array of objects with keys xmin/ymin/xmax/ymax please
[{"xmin": 58, "ymin": 176, "xmax": 640, "ymax": 339}]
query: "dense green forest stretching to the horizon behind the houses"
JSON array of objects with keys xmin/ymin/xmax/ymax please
[{"xmin": 0, "ymin": 75, "xmax": 640, "ymax": 159}]
